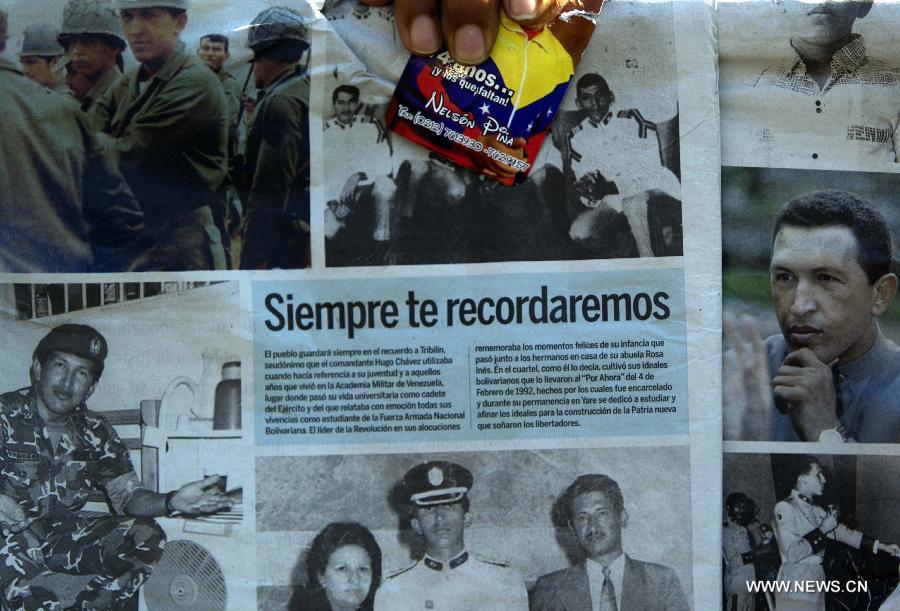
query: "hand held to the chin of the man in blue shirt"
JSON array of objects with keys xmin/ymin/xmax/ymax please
[{"xmin": 772, "ymin": 348, "xmax": 840, "ymax": 441}]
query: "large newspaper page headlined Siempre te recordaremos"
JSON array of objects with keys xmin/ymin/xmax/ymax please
[{"xmin": 0, "ymin": 0, "xmax": 716, "ymax": 611}]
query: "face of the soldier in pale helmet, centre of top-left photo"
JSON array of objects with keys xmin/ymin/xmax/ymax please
[{"xmin": 122, "ymin": 7, "xmax": 187, "ymax": 66}]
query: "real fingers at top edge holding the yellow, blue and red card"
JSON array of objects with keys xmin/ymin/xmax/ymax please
[{"xmin": 361, "ymin": 0, "xmax": 566, "ymax": 64}]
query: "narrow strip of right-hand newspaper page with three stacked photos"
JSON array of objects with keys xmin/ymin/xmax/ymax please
[{"xmin": 718, "ymin": 0, "xmax": 900, "ymax": 609}]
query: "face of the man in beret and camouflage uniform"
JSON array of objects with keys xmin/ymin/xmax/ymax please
[{"xmin": 34, "ymin": 352, "xmax": 96, "ymax": 416}]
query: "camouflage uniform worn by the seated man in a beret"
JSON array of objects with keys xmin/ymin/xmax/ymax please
[{"xmin": 0, "ymin": 391, "xmax": 165, "ymax": 609}]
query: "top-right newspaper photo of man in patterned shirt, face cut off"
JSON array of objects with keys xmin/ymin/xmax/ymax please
[{"xmin": 719, "ymin": 0, "xmax": 900, "ymax": 172}]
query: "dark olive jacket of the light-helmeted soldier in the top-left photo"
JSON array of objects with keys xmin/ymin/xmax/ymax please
[{"xmin": 98, "ymin": 43, "xmax": 228, "ymax": 226}]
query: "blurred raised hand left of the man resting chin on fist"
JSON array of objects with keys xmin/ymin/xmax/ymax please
[{"xmin": 722, "ymin": 314, "xmax": 772, "ymax": 441}]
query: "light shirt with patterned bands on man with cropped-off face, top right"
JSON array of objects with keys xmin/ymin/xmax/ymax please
[{"xmin": 721, "ymin": 36, "xmax": 900, "ymax": 172}]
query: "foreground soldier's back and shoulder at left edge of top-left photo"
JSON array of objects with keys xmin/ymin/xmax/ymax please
[{"xmin": 0, "ymin": 5, "xmax": 142, "ymax": 273}]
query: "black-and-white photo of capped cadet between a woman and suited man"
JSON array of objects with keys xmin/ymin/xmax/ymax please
[{"xmin": 256, "ymin": 447, "xmax": 691, "ymax": 611}]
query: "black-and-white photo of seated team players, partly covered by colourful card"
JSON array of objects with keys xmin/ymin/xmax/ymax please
[{"xmin": 324, "ymin": 0, "xmax": 682, "ymax": 266}]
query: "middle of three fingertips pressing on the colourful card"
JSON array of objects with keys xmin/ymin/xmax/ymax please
[{"xmin": 441, "ymin": 0, "xmax": 500, "ymax": 64}]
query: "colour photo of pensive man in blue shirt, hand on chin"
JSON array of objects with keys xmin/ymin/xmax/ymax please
[{"xmin": 724, "ymin": 172, "xmax": 900, "ymax": 444}]
